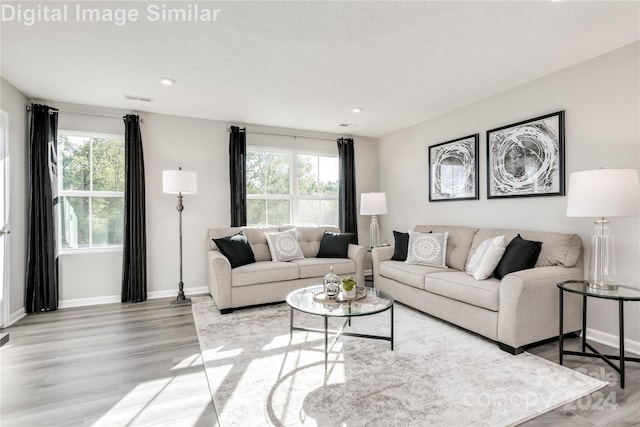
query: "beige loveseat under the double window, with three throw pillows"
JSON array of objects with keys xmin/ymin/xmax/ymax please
[{"xmin": 207, "ymin": 226, "xmax": 367, "ymax": 313}]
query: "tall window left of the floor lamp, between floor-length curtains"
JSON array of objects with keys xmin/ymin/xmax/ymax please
[{"xmin": 58, "ymin": 131, "xmax": 124, "ymax": 250}]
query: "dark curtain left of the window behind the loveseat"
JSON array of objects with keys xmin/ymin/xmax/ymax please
[{"xmin": 229, "ymin": 126, "xmax": 247, "ymax": 227}]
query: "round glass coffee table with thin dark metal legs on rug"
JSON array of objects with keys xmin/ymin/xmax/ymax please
[{"xmin": 287, "ymin": 285, "xmax": 394, "ymax": 369}]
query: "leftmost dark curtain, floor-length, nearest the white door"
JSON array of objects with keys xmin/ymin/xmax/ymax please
[{"xmin": 25, "ymin": 104, "xmax": 58, "ymax": 313}]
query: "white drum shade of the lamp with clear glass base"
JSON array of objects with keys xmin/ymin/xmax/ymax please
[{"xmin": 567, "ymin": 169, "xmax": 640, "ymax": 218}]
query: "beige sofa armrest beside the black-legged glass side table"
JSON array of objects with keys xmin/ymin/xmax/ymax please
[{"xmin": 498, "ymin": 266, "xmax": 584, "ymax": 348}]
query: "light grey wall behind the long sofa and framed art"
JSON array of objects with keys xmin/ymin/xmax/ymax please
[{"xmin": 379, "ymin": 43, "xmax": 640, "ymax": 351}]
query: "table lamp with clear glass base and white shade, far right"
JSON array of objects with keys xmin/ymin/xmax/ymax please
[{"xmin": 567, "ymin": 169, "xmax": 640, "ymax": 291}]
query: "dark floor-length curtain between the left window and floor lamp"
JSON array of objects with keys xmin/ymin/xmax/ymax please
[{"xmin": 122, "ymin": 114, "xmax": 147, "ymax": 302}]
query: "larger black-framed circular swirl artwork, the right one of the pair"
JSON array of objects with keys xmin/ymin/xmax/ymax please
[{"xmin": 487, "ymin": 111, "xmax": 565, "ymax": 199}]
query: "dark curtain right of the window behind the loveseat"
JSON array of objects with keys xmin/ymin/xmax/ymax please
[{"xmin": 337, "ymin": 138, "xmax": 358, "ymax": 243}]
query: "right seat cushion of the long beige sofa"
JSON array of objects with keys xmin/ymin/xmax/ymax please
[{"xmin": 424, "ymin": 271, "xmax": 500, "ymax": 311}]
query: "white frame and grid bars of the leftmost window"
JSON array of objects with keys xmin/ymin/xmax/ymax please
[{"xmin": 56, "ymin": 129, "xmax": 126, "ymax": 255}]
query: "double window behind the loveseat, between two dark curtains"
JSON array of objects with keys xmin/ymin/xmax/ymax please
[{"xmin": 247, "ymin": 147, "xmax": 338, "ymax": 226}]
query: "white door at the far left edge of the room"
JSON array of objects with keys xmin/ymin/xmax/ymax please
[{"xmin": 0, "ymin": 111, "xmax": 10, "ymax": 327}]
